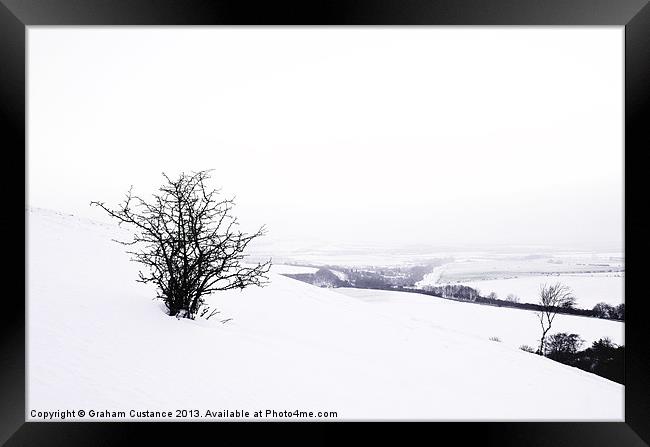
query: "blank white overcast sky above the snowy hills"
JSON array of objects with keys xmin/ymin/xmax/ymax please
[{"xmin": 28, "ymin": 27, "xmax": 623, "ymax": 250}]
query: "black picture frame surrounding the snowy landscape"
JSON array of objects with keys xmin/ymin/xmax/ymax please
[{"xmin": 0, "ymin": 0, "xmax": 650, "ymax": 446}]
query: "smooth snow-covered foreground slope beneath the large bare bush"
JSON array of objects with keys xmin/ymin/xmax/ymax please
[{"xmin": 27, "ymin": 209, "xmax": 623, "ymax": 420}]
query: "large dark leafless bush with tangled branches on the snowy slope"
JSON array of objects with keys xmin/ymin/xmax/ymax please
[{"xmin": 91, "ymin": 171, "xmax": 271, "ymax": 319}]
